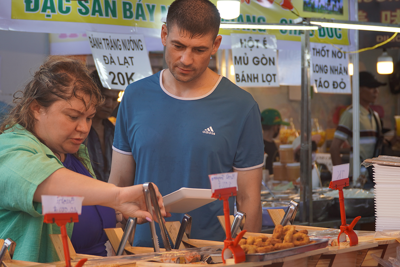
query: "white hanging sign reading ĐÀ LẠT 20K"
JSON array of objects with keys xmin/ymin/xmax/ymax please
[{"xmin": 87, "ymin": 32, "xmax": 152, "ymax": 90}]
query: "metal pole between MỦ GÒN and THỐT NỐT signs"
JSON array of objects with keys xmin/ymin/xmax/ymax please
[{"xmin": 300, "ymin": 27, "xmax": 313, "ymax": 224}]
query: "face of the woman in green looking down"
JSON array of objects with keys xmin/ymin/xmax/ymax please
[{"xmin": 33, "ymin": 93, "xmax": 96, "ymax": 161}]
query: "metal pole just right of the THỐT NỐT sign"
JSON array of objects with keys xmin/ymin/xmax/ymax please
[{"xmin": 352, "ymin": 1, "xmax": 360, "ymax": 185}]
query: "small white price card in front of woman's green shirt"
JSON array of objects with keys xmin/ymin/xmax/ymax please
[{"xmin": 42, "ymin": 196, "xmax": 84, "ymax": 215}]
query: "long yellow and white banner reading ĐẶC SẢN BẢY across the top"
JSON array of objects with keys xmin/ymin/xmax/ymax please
[{"xmin": 0, "ymin": 0, "xmax": 349, "ymax": 45}]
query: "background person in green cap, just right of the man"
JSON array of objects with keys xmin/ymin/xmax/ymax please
[{"xmin": 261, "ymin": 108, "xmax": 290, "ymax": 174}]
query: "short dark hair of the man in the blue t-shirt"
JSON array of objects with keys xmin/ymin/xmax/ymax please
[{"xmin": 167, "ymin": 0, "xmax": 221, "ymax": 38}]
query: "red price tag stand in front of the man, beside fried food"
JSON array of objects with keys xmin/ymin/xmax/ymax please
[{"xmin": 212, "ymin": 187, "xmax": 246, "ymax": 263}]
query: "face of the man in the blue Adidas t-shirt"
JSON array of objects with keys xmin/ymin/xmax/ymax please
[{"xmin": 161, "ymin": 25, "xmax": 222, "ymax": 83}]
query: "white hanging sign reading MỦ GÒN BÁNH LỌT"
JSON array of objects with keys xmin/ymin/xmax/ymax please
[{"xmin": 231, "ymin": 34, "xmax": 279, "ymax": 87}]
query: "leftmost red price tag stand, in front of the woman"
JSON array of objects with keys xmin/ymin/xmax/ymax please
[{"xmin": 43, "ymin": 213, "xmax": 87, "ymax": 267}]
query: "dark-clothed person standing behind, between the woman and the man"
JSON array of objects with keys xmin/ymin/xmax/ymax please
[{"xmin": 87, "ymin": 70, "xmax": 121, "ymax": 182}]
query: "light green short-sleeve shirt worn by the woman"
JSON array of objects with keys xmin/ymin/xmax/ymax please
[{"xmin": 0, "ymin": 125, "xmax": 73, "ymax": 262}]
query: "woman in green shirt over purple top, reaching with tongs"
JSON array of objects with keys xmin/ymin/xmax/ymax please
[{"xmin": 0, "ymin": 56, "xmax": 166, "ymax": 262}]
